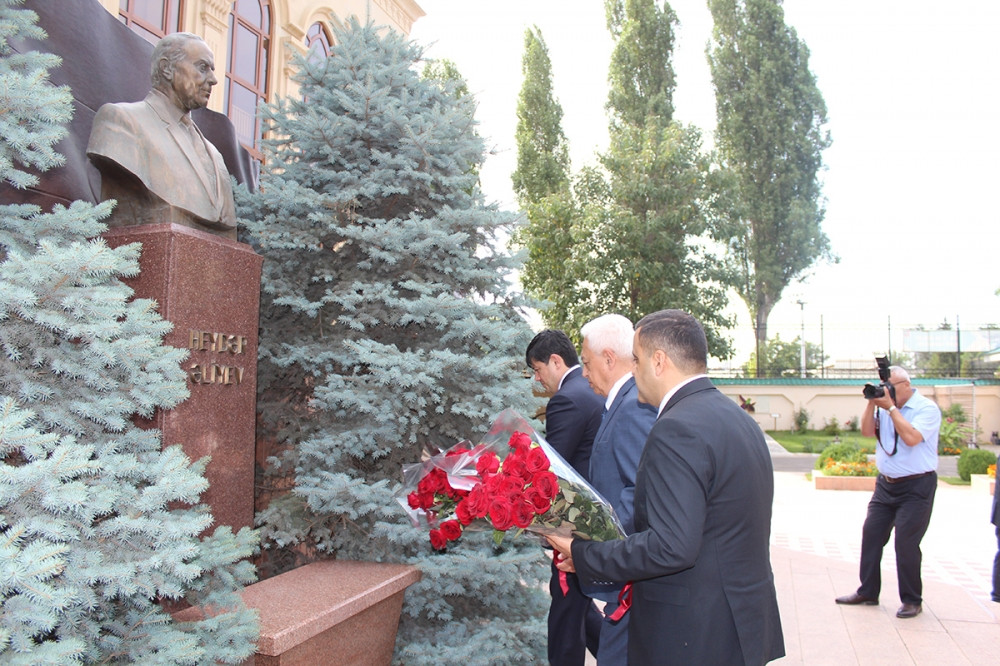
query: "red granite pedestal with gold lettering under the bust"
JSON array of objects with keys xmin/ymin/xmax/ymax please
[{"xmin": 104, "ymin": 224, "xmax": 263, "ymax": 531}]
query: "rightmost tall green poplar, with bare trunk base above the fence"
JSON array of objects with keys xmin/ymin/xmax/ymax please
[{"xmin": 708, "ymin": 0, "xmax": 831, "ymax": 372}]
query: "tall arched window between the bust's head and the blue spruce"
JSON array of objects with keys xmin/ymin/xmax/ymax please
[{"xmin": 223, "ymin": 0, "xmax": 271, "ymax": 159}]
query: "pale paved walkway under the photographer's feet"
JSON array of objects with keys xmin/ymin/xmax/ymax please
[{"xmin": 771, "ymin": 438, "xmax": 1000, "ymax": 666}]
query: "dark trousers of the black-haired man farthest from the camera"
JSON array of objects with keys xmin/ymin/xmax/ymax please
[{"xmin": 549, "ymin": 565, "xmax": 602, "ymax": 666}]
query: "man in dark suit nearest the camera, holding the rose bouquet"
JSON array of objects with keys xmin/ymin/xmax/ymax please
[{"xmin": 549, "ymin": 310, "xmax": 785, "ymax": 665}]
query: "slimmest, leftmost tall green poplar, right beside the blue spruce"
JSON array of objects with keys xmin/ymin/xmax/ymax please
[{"xmin": 511, "ymin": 27, "xmax": 578, "ymax": 335}]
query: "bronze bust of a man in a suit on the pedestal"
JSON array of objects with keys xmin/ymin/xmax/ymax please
[{"xmin": 87, "ymin": 32, "xmax": 236, "ymax": 240}]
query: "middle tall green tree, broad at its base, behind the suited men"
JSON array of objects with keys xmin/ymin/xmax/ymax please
[{"xmin": 574, "ymin": 0, "xmax": 730, "ymax": 358}]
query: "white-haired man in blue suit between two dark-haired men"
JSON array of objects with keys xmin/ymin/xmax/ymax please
[{"xmin": 580, "ymin": 314, "xmax": 656, "ymax": 666}]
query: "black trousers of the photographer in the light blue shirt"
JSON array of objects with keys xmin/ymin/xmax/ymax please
[{"xmin": 858, "ymin": 472, "xmax": 937, "ymax": 604}]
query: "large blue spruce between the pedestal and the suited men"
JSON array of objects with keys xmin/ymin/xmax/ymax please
[{"xmin": 238, "ymin": 20, "xmax": 548, "ymax": 666}]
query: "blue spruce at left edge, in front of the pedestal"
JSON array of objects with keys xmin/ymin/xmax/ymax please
[{"xmin": 0, "ymin": 0, "xmax": 257, "ymax": 664}]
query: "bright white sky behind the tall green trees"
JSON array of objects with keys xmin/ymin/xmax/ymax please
[{"xmin": 410, "ymin": 0, "xmax": 1000, "ymax": 366}]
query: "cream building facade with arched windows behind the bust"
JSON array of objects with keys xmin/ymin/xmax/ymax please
[{"xmin": 97, "ymin": 0, "xmax": 424, "ymax": 159}]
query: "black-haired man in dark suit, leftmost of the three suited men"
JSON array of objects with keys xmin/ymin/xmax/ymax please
[{"xmin": 525, "ymin": 329, "xmax": 604, "ymax": 666}]
